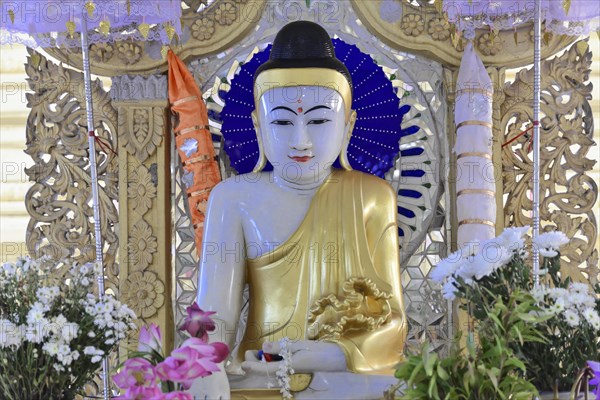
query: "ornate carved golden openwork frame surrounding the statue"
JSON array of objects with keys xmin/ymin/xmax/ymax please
[{"xmin": 26, "ymin": 0, "xmax": 600, "ymax": 372}]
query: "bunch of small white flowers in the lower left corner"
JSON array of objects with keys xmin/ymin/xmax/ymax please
[{"xmin": 0, "ymin": 258, "xmax": 136, "ymax": 400}]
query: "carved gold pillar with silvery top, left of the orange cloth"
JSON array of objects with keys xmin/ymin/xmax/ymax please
[{"xmin": 111, "ymin": 76, "xmax": 173, "ymax": 352}]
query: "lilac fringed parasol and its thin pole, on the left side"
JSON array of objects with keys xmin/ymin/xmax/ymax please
[{"xmin": 0, "ymin": 0, "xmax": 181, "ymax": 399}]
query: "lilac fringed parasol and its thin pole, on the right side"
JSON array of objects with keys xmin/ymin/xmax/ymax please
[{"xmin": 435, "ymin": 0, "xmax": 600, "ymax": 285}]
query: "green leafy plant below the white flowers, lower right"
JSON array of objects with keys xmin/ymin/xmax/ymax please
[{"xmin": 396, "ymin": 291, "xmax": 544, "ymax": 400}]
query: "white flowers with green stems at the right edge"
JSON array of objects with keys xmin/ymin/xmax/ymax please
[{"xmin": 432, "ymin": 227, "xmax": 600, "ymax": 391}]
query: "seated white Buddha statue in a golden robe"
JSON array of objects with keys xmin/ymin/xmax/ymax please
[{"xmin": 192, "ymin": 21, "xmax": 407, "ymax": 399}]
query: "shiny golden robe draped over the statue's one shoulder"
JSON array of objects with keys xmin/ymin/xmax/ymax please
[{"xmin": 238, "ymin": 170, "xmax": 407, "ymax": 374}]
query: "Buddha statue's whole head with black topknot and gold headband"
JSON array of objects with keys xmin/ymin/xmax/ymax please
[{"xmin": 252, "ymin": 21, "xmax": 356, "ymax": 180}]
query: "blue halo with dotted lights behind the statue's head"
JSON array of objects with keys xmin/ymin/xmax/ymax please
[{"xmin": 219, "ymin": 39, "xmax": 422, "ymax": 178}]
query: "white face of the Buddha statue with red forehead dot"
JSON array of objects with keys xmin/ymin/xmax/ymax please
[{"xmin": 255, "ymin": 86, "xmax": 349, "ymax": 181}]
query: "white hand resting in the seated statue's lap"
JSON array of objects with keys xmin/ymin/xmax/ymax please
[{"xmin": 242, "ymin": 340, "xmax": 347, "ymax": 376}]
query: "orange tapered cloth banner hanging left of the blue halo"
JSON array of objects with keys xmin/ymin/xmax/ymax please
[{"xmin": 167, "ymin": 50, "xmax": 221, "ymax": 257}]
